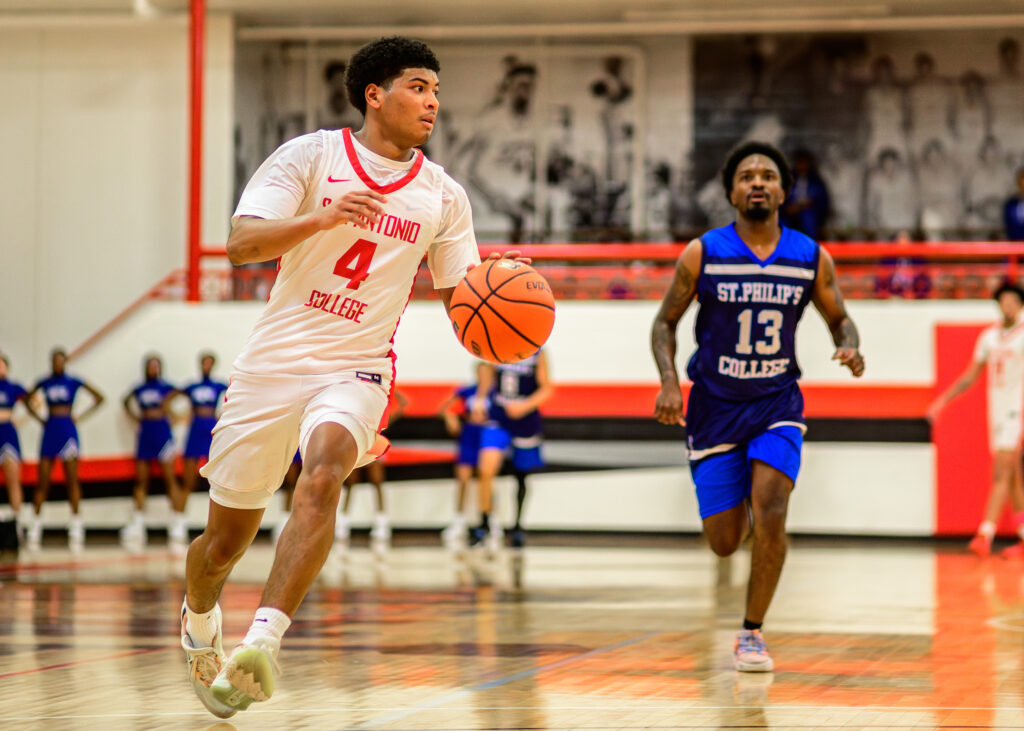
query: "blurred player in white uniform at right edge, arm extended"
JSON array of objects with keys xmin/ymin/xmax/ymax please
[{"xmin": 928, "ymin": 283, "xmax": 1024, "ymax": 557}]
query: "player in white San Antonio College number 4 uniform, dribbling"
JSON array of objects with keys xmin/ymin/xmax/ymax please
[{"xmin": 181, "ymin": 38, "xmax": 525, "ymax": 718}]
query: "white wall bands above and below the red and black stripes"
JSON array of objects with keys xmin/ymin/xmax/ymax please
[{"xmin": 9, "ymin": 301, "xmax": 966, "ymax": 535}]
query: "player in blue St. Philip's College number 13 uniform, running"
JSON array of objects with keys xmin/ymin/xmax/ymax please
[{"xmin": 651, "ymin": 142, "xmax": 864, "ymax": 672}]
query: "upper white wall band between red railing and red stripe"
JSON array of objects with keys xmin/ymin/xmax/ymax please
[{"xmin": 28, "ymin": 292, "xmax": 995, "ymax": 458}]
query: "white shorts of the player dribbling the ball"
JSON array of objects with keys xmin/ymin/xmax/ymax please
[{"xmin": 201, "ymin": 372, "xmax": 388, "ymax": 510}]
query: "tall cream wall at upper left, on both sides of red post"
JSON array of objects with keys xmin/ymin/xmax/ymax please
[{"xmin": 0, "ymin": 15, "xmax": 233, "ymax": 380}]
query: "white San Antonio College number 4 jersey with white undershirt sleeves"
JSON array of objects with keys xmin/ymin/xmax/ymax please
[{"xmin": 234, "ymin": 129, "xmax": 480, "ymax": 376}]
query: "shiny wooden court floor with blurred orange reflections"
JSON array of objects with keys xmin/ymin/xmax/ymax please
[{"xmin": 0, "ymin": 538, "xmax": 1024, "ymax": 731}]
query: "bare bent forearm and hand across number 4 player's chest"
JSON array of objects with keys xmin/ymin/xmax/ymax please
[{"xmin": 227, "ymin": 190, "xmax": 387, "ymax": 266}]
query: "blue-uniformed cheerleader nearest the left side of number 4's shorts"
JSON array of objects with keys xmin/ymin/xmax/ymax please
[{"xmin": 167, "ymin": 352, "xmax": 227, "ymax": 552}]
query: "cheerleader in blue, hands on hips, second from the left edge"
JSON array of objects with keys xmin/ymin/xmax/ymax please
[{"xmin": 25, "ymin": 348, "xmax": 103, "ymax": 553}]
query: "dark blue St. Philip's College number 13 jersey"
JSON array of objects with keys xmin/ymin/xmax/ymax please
[{"xmin": 686, "ymin": 224, "xmax": 820, "ymax": 401}]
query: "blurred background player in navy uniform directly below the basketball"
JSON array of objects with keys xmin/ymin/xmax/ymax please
[{"xmin": 492, "ymin": 350, "xmax": 554, "ymax": 548}]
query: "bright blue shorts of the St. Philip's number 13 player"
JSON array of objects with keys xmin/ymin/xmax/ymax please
[{"xmin": 690, "ymin": 424, "xmax": 804, "ymax": 520}]
